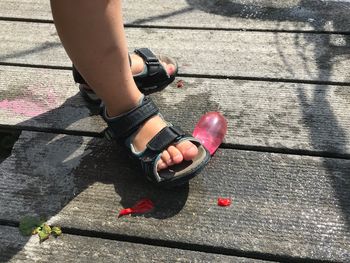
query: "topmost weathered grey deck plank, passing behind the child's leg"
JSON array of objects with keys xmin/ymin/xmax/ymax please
[{"xmin": 0, "ymin": 0, "xmax": 350, "ymax": 32}]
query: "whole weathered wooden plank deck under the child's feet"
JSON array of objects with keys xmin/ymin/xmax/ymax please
[{"xmin": 0, "ymin": 0, "xmax": 350, "ymax": 262}]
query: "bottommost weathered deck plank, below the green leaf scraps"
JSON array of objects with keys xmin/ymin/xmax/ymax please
[{"xmin": 0, "ymin": 226, "xmax": 266, "ymax": 263}]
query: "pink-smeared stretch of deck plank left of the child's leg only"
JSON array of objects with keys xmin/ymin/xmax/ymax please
[{"xmin": 0, "ymin": 67, "xmax": 106, "ymax": 132}]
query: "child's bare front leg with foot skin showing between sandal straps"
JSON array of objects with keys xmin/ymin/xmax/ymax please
[{"xmin": 51, "ymin": 0, "xmax": 198, "ymax": 169}]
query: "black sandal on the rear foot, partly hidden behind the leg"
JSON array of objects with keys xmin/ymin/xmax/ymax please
[{"xmin": 73, "ymin": 48, "xmax": 178, "ymax": 104}]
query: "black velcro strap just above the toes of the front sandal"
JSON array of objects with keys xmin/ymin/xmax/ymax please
[{"xmin": 147, "ymin": 126, "xmax": 186, "ymax": 152}]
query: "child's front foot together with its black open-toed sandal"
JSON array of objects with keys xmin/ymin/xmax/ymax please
[{"xmin": 103, "ymin": 97, "xmax": 210, "ymax": 187}]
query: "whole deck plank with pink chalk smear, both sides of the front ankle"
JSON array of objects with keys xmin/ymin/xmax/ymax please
[{"xmin": 0, "ymin": 66, "xmax": 350, "ymax": 154}]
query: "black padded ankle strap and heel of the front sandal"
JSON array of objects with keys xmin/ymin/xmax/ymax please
[{"xmin": 103, "ymin": 96, "xmax": 159, "ymax": 140}]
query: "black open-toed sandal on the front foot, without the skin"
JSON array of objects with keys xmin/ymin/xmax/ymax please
[{"xmin": 102, "ymin": 97, "xmax": 210, "ymax": 187}]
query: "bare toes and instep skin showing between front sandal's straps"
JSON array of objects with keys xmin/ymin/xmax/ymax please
[{"xmin": 133, "ymin": 115, "xmax": 198, "ymax": 171}]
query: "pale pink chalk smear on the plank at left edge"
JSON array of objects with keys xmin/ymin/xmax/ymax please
[{"xmin": 0, "ymin": 99, "xmax": 49, "ymax": 117}]
